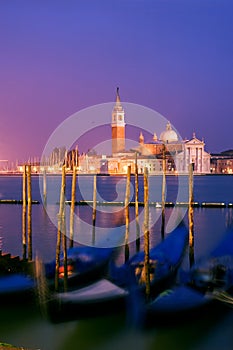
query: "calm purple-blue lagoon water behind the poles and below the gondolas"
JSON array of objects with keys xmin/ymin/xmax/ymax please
[{"xmin": 0, "ymin": 175, "xmax": 233, "ymax": 350}]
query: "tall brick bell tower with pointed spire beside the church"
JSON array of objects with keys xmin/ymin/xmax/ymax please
[{"xmin": 112, "ymin": 88, "xmax": 125, "ymax": 154}]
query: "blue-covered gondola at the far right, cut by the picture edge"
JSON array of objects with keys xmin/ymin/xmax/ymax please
[{"xmin": 142, "ymin": 230, "xmax": 233, "ymax": 326}]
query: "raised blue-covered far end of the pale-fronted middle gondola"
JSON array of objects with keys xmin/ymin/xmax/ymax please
[{"xmin": 111, "ymin": 222, "xmax": 188, "ymax": 295}]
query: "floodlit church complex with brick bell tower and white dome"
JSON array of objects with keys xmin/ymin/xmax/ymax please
[{"xmin": 79, "ymin": 88, "xmax": 210, "ymax": 174}]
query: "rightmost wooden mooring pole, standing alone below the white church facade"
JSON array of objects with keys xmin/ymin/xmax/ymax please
[{"xmin": 188, "ymin": 164, "xmax": 194, "ymax": 267}]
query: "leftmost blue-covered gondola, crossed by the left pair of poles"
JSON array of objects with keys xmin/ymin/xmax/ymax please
[{"xmin": 0, "ymin": 247, "xmax": 113, "ymax": 303}]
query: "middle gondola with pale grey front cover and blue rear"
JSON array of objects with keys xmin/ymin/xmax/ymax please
[{"xmin": 40, "ymin": 224, "xmax": 188, "ymax": 322}]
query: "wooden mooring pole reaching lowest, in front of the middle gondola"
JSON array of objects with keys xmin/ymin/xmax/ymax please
[{"xmin": 144, "ymin": 167, "xmax": 150, "ymax": 300}]
